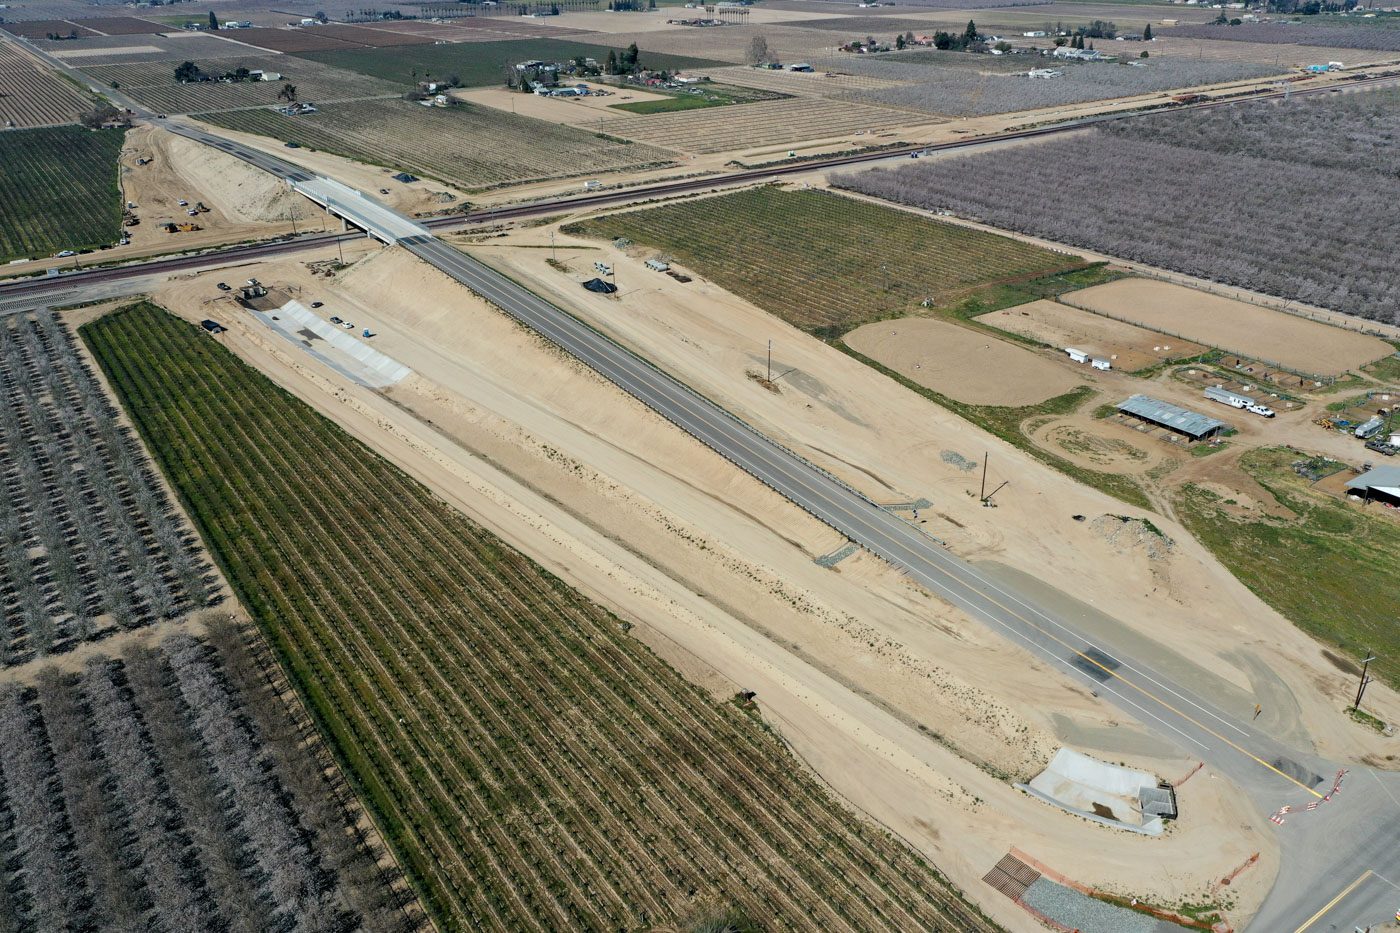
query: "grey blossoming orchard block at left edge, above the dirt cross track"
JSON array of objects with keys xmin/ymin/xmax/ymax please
[{"xmin": 0, "ymin": 314, "xmax": 213, "ymax": 665}]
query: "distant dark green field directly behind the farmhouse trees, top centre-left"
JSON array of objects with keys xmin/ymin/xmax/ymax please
[{"xmin": 288, "ymin": 39, "xmax": 715, "ymax": 87}]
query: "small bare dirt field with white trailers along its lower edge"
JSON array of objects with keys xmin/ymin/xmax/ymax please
[{"xmin": 977, "ymin": 300, "xmax": 1205, "ymax": 373}]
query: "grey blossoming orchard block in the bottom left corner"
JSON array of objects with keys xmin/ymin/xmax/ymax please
[{"xmin": 0, "ymin": 622, "xmax": 421, "ymax": 933}]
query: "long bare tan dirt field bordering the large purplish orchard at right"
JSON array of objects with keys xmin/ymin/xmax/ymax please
[{"xmin": 1063, "ymin": 279, "xmax": 1394, "ymax": 375}]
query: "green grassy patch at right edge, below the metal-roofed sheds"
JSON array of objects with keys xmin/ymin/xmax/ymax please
[{"xmin": 1177, "ymin": 448, "xmax": 1400, "ymax": 685}]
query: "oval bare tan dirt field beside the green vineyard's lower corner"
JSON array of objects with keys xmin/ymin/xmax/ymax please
[{"xmin": 843, "ymin": 318, "xmax": 1079, "ymax": 405}]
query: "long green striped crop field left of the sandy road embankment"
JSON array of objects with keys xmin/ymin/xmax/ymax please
[{"xmin": 84, "ymin": 305, "xmax": 994, "ymax": 932}]
